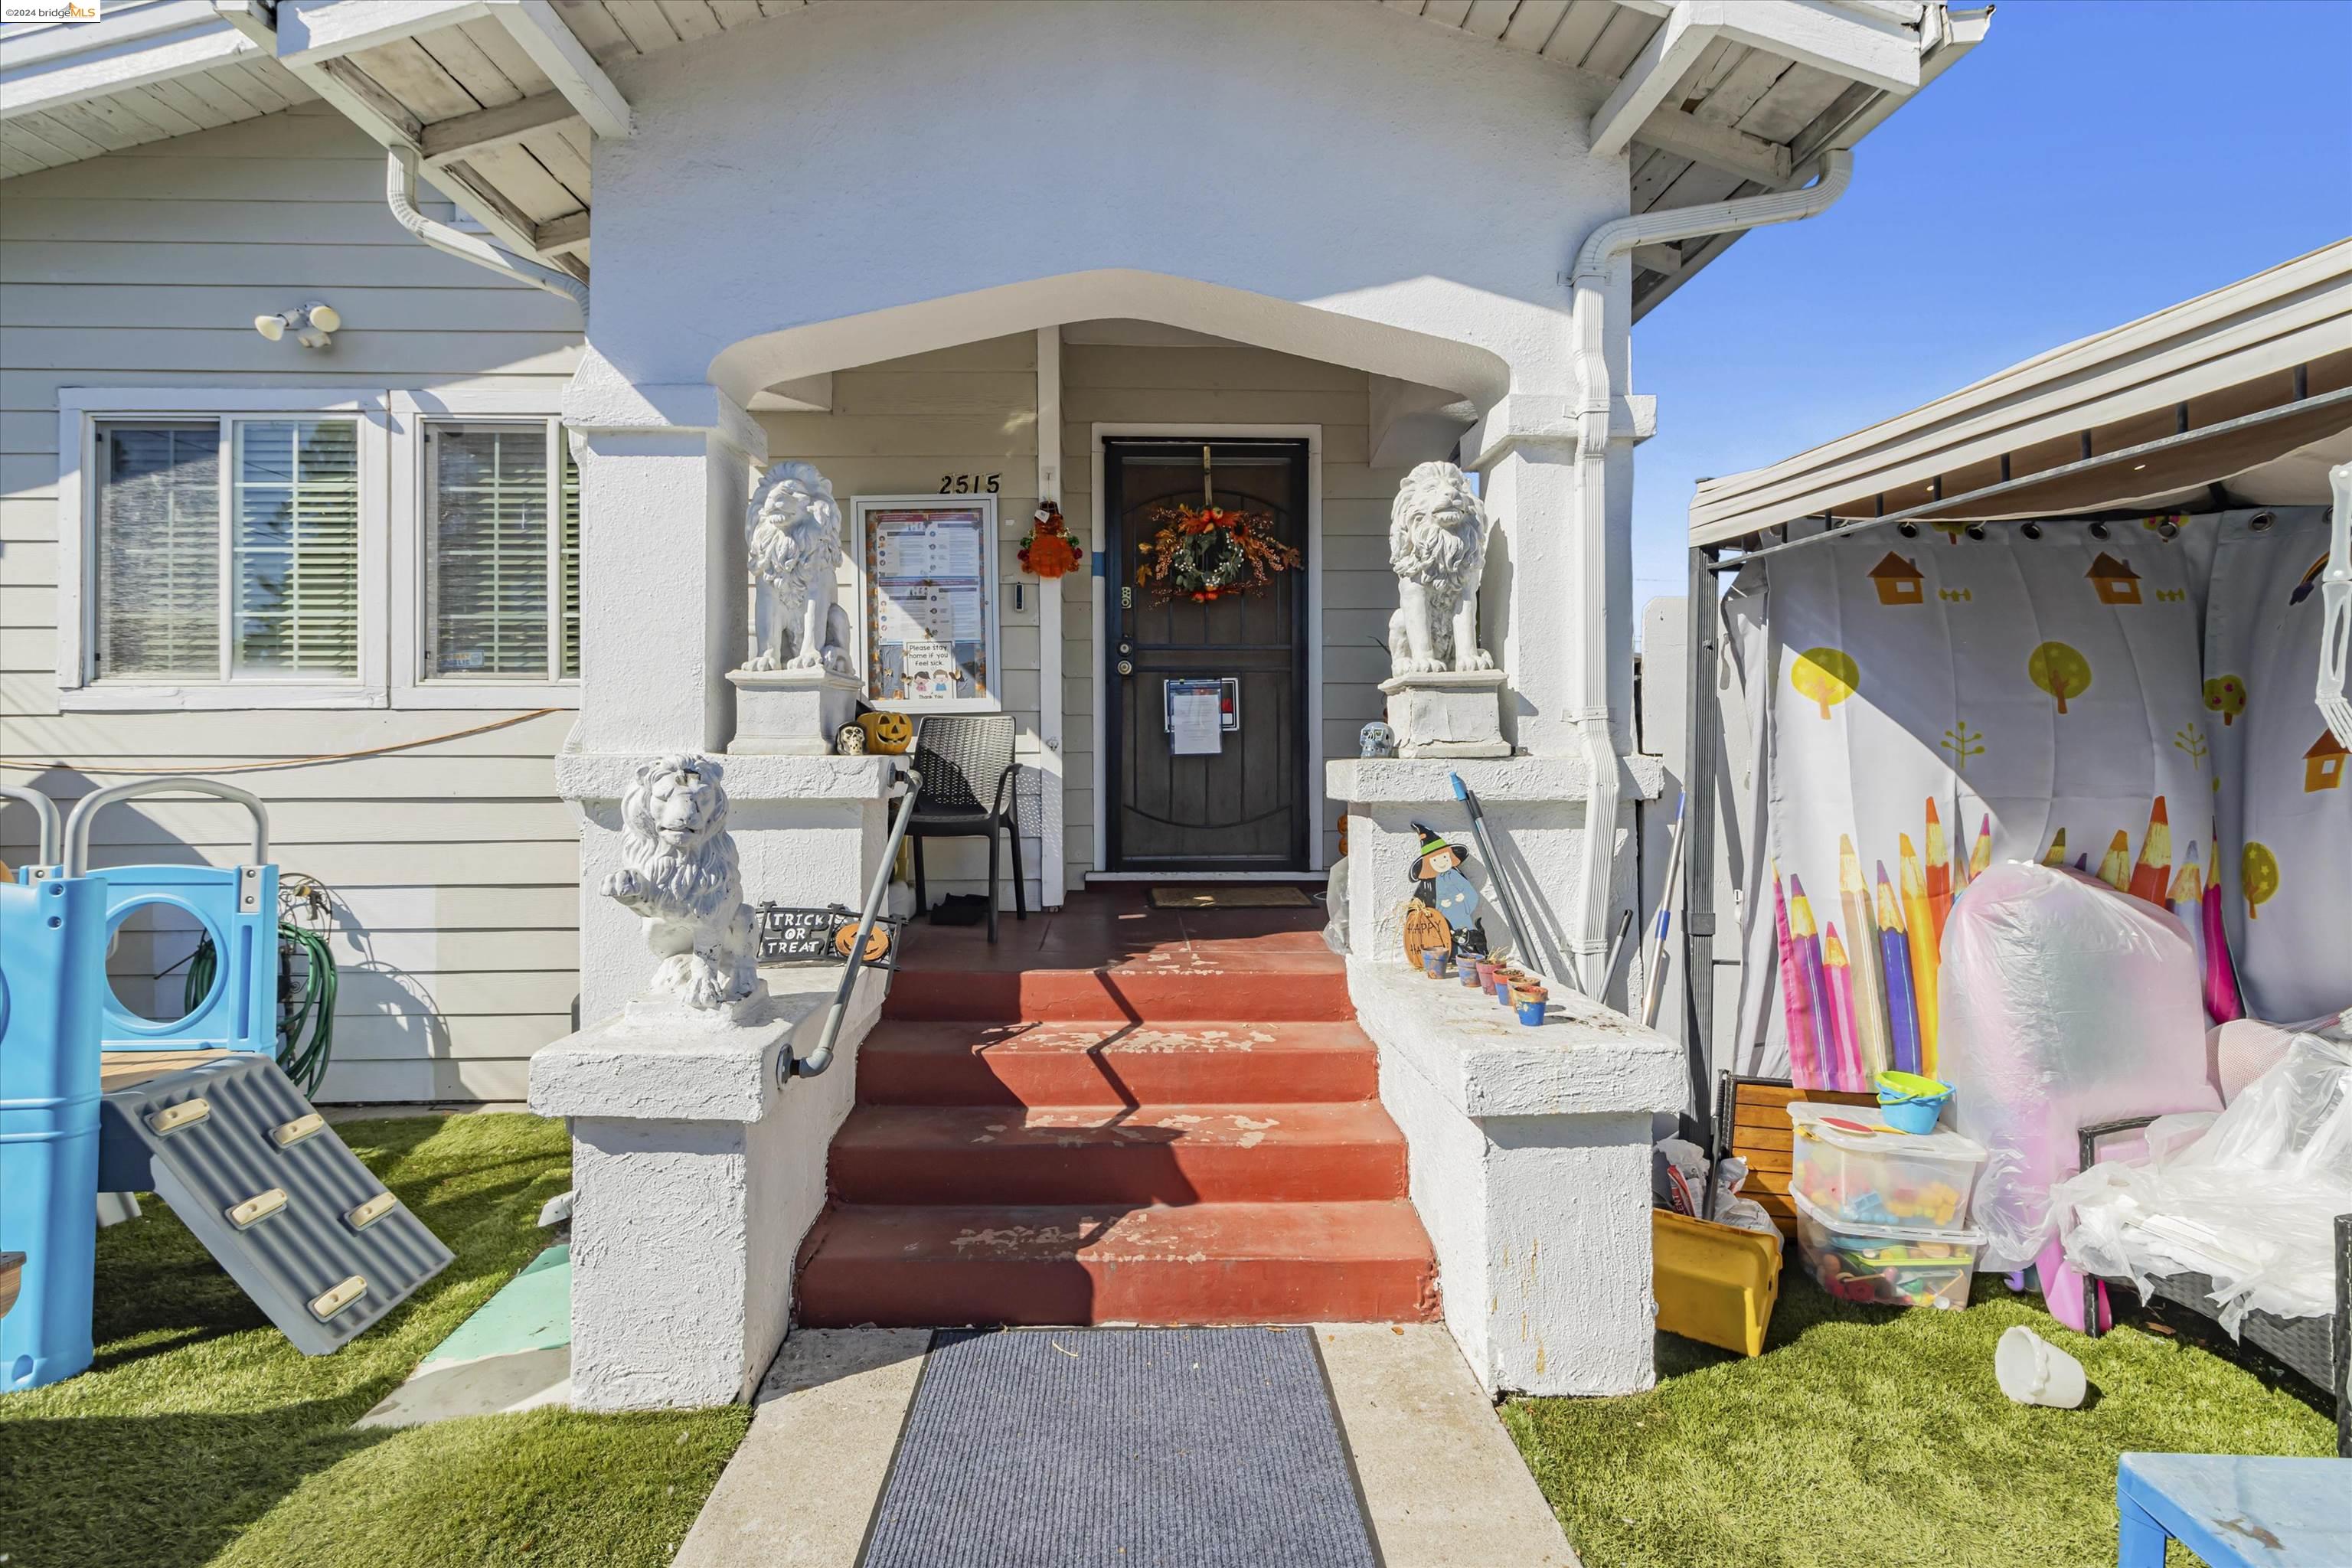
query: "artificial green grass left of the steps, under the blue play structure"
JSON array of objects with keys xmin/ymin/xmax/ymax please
[{"xmin": 0, "ymin": 1116, "xmax": 750, "ymax": 1568}]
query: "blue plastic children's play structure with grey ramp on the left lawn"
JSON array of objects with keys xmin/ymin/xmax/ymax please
[{"xmin": 0, "ymin": 778, "xmax": 449, "ymax": 1392}]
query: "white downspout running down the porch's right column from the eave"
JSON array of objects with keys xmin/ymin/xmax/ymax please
[{"xmin": 1569, "ymin": 148, "xmax": 1854, "ymax": 1001}]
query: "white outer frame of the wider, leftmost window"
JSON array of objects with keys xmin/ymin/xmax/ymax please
[{"xmin": 57, "ymin": 386, "xmax": 390, "ymax": 712}]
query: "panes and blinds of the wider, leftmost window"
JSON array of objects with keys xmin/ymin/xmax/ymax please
[{"xmin": 92, "ymin": 419, "xmax": 360, "ymax": 681}]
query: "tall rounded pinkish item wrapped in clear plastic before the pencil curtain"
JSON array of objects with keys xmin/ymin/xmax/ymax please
[{"xmin": 1938, "ymin": 861, "xmax": 2220, "ymax": 1272}]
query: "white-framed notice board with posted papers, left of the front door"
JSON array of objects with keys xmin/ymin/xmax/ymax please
[{"xmin": 856, "ymin": 496, "xmax": 995, "ymax": 707}]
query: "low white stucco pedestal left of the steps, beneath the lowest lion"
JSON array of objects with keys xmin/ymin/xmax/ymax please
[{"xmin": 531, "ymin": 966, "xmax": 882, "ymax": 1410}]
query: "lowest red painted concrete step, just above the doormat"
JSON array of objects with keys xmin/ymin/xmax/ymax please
[{"xmin": 797, "ymin": 1199, "xmax": 1437, "ymax": 1328}]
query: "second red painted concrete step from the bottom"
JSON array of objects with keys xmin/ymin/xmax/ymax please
[{"xmin": 830, "ymin": 1100, "xmax": 1404, "ymax": 1204}]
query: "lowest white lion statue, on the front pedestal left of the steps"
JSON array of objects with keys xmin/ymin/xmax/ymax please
[{"xmin": 602, "ymin": 755, "xmax": 760, "ymax": 1011}]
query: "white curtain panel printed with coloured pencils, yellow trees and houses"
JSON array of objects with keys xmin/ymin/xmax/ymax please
[{"xmin": 1724, "ymin": 518, "xmax": 2234, "ymax": 1089}]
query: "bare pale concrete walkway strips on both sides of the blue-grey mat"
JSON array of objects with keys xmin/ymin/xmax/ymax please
[{"xmin": 675, "ymin": 1324, "xmax": 1576, "ymax": 1568}]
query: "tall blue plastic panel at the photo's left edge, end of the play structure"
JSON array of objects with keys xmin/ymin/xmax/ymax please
[{"xmin": 0, "ymin": 877, "xmax": 106, "ymax": 1392}]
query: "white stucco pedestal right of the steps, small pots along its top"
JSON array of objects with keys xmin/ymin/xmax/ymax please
[{"xmin": 1348, "ymin": 959, "xmax": 1687, "ymax": 1394}]
